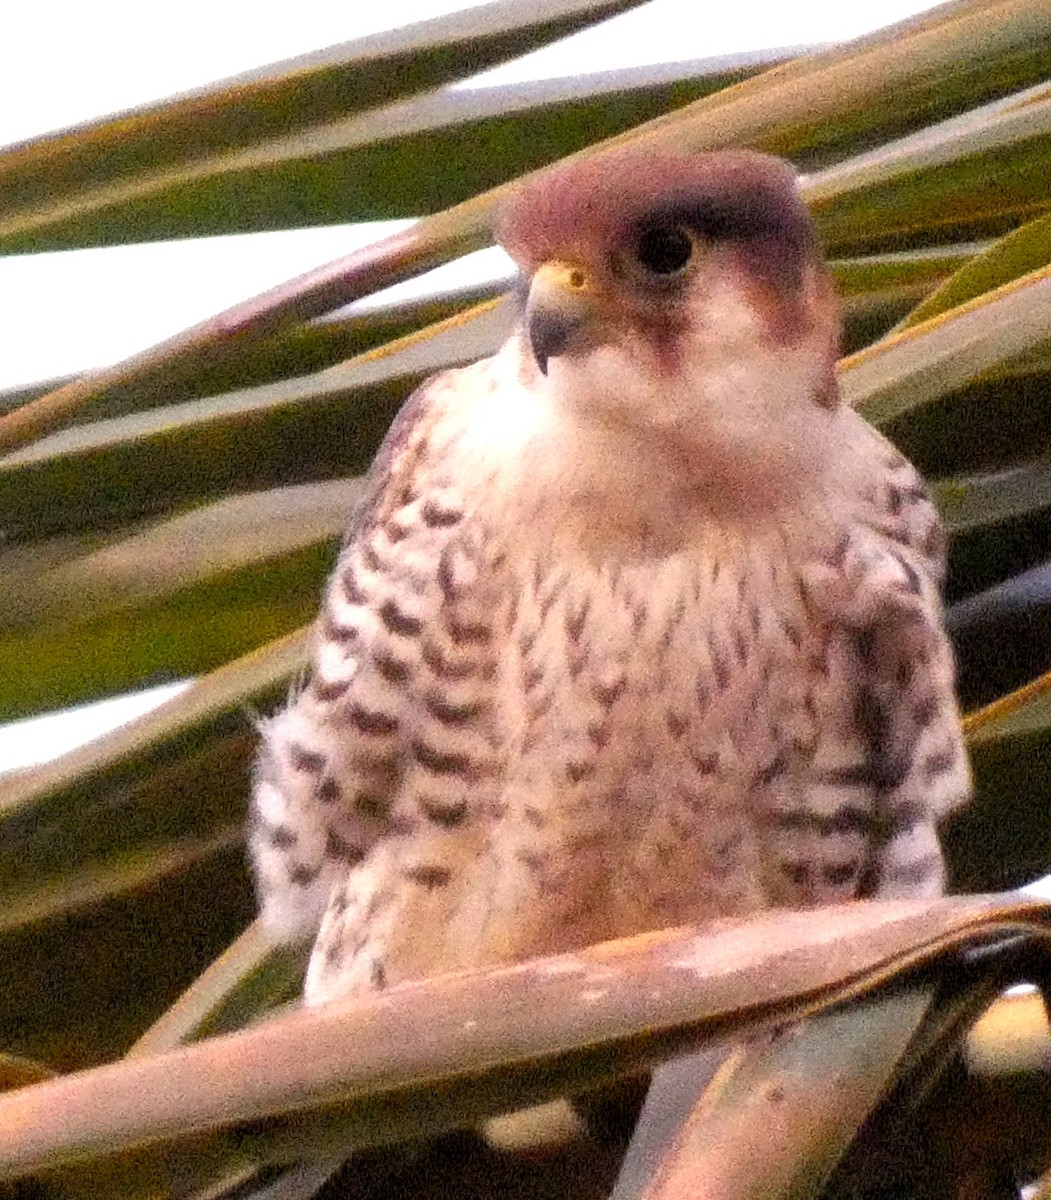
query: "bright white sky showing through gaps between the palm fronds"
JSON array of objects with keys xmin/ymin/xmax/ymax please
[{"xmin": 0, "ymin": 0, "xmax": 932, "ymax": 772}]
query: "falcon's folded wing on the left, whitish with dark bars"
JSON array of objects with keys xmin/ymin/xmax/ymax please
[{"xmin": 250, "ymin": 364, "xmax": 513, "ymax": 938}]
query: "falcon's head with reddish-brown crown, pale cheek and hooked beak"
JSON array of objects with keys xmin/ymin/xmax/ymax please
[{"xmin": 499, "ymin": 145, "xmax": 840, "ymax": 501}]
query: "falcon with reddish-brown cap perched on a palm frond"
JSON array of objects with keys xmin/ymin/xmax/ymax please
[{"xmin": 248, "ymin": 142, "xmax": 971, "ymax": 1004}]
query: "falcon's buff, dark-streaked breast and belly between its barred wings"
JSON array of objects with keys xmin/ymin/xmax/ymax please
[{"xmin": 479, "ymin": 541, "xmax": 829, "ymax": 944}]
